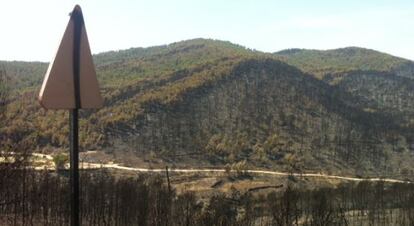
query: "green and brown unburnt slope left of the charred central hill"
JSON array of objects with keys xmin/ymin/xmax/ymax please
[{"xmin": 1, "ymin": 39, "xmax": 253, "ymax": 152}]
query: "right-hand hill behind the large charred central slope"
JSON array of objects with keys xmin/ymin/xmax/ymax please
[{"xmin": 276, "ymin": 47, "xmax": 414, "ymax": 157}]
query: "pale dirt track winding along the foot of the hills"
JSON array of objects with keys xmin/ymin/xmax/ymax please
[{"xmin": 33, "ymin": 153, "xmax": 413, "ymax": 184}]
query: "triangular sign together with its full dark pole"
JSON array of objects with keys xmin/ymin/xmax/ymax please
[{"xmin": 39, "ymin": 5, "xmax": 103, "ymax": 226}]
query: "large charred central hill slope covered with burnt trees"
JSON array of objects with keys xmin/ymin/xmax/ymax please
[{"xmin": 102, "ymin": 59, "xmax": 410, "ymax": 175}]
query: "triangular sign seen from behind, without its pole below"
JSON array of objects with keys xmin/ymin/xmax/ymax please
[{"xmin": 39, "ymin": 6, "xmax": 103, "ymax": 109}]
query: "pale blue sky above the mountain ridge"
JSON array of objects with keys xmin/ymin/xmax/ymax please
[{"xmin": 0, "ymin": 0, "xmax": 414, "ymax": 61}]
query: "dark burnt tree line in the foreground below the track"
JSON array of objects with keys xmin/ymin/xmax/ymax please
[{"xmin": 0, "ymin": 167, "xmax": 414, "ymax": 226}]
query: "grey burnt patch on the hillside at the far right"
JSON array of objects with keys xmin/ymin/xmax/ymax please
[{"xmin": 325, "ymin": 71, "xmax": 414, "ymax": 128}]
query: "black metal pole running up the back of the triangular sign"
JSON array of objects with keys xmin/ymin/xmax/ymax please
[{"xmin": 69, "ymin": 6, "xmax": 83, "ymax": 226}]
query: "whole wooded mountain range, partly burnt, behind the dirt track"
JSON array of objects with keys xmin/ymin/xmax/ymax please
[{"xmin": 0, "ymin": 39, "xmax": 414, "ymax": 177}]
